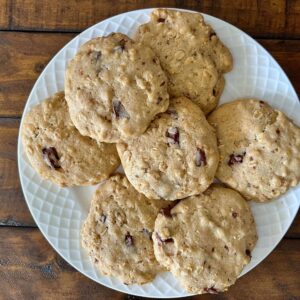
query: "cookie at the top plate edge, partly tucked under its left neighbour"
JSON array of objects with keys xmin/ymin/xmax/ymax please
[{"xmin": 135, "ymin": 9, "xmax": 232, "ymax": 114}]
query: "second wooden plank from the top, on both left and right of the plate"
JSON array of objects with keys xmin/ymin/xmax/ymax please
[{"xmin": 0, "ymin": 32, "xmax": 300, "ymax": 117}]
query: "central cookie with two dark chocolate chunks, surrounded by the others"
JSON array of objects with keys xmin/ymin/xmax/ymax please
[{"xmin": 117, "ymin": 97, "xmax": 219, "ymax": 200}]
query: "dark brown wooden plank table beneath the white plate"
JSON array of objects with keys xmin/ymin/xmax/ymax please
[{"xmin": 0, "ymin": 0, "xmax": 300, "ymax": 299}]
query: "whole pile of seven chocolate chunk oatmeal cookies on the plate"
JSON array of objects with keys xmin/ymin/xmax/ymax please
[{"xmin": 22, "ymin": 9, "xmax": 300, "ymax": 294}]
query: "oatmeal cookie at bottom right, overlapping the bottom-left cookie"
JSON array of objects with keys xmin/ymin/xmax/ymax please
[{"xmin": 152, "ymin": 185, "xmax": 257, "ymax": 294}]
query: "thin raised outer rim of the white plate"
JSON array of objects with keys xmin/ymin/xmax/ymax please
[{"xmin": 17, "ymin": 7, "xmax": 300, "ymax": 298}]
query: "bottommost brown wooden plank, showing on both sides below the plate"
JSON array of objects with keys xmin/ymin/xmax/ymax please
[{"xmin": 0, "ymin": 227, "xmax": 300, "ymax": 300}]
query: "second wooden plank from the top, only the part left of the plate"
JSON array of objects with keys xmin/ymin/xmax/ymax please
[{"xmin": 0, "ymin": 31, "xmax": 74, "ymax": 116}]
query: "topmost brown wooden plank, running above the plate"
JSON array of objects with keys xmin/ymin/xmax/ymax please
[{"xmin": 2, "ymin": 0, "xmax": 300, "ymax": 38}]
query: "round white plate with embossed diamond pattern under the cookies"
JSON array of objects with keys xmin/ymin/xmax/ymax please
[{"xmin": 18, "ymin": 9, "xmax": 300, "ymax": 298}]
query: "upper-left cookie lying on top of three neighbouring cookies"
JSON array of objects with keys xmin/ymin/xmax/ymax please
[{"xmin": 65, "ymin": 33, "xmax": 169, "ymax": 143}]
